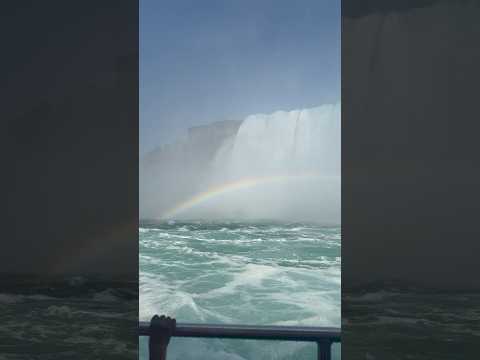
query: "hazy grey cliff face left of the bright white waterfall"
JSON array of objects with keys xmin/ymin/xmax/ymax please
[{"xmin": 140, "ymin": 120, "xmax": 242, "ymax": 219}]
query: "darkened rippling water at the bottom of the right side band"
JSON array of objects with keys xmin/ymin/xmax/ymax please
[{"xmin": 342, "ymin": 284, "xmax": 480, "ymax": 360}]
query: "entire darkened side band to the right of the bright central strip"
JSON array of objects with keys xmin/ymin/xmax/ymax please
[{"xmin": 342, "ymin": 0, "xmax": 480, "ymax": 359}]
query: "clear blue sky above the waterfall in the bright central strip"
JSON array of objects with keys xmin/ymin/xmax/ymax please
[{"xmin": 140, "ymin": 0, "xmax": 341, "ymax": 155}]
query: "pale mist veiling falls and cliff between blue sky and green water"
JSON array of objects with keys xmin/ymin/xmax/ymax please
[{"xmin": 140, "ymin": 103, "xmax": 340, "ymax": 224}]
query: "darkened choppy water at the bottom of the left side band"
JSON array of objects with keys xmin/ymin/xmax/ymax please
[{"xmin": 0, "ymin": 277, "xmax": 138, "ymax": 360}]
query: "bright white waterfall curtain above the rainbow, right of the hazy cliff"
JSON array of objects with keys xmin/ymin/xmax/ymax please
[{"xmin": 226, "ymin": 104, "xmax": 340, "ymax": 178}]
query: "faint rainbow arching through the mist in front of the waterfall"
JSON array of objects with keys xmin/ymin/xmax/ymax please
[{"xmin": 160, "ymin": 173, "xmax": 338, "ymax": 220}]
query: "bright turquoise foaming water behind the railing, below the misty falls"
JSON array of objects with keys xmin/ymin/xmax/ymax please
[{"xmin": 139, "ymin": 221, "xmax": 341, "ymax": 360}]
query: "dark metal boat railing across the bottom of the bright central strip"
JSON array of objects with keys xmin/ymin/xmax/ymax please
[{"xmin": 139, "ymin": 322, "xmax": 341, "ymax": 360}]
